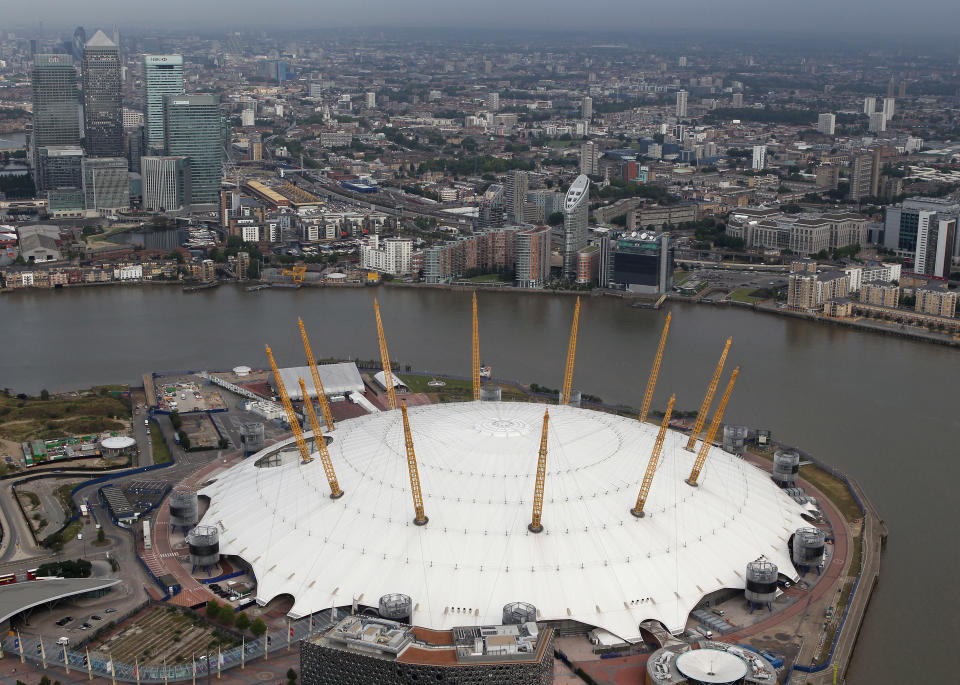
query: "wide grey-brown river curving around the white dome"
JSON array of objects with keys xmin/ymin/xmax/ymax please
[{"xmin": 0, "ymin": 286, "xmax": 960, "ymax": 684}]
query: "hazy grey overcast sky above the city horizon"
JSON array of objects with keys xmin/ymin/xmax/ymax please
[{"xmin": 11, "ymin": 0, "xmax": 960, "ymax": 39}]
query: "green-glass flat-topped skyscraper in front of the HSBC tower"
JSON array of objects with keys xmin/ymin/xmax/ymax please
[{"xmin": 163, "ymin": 95, "xmax": 223, "ymax": 207}]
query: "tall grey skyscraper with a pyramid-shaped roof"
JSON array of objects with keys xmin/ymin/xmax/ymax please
[{"xmin": 83, "ymin": 30, "xmax": 123, "ymax": 157}]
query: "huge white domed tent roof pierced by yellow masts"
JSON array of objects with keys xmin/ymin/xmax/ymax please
[{"xmin": 200, "ymin": 402, "xmax": 806, "ymax": 640}]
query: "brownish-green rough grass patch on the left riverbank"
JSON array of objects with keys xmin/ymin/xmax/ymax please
[{"xmin": 0, "ymin": 393, "xmax": 130, "ymax": 442}]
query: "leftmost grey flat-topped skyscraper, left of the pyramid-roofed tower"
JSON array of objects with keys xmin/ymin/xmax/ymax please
[{"xmin": 30, "ymin": 55, "xmax": 80, "ymax": 190}]
